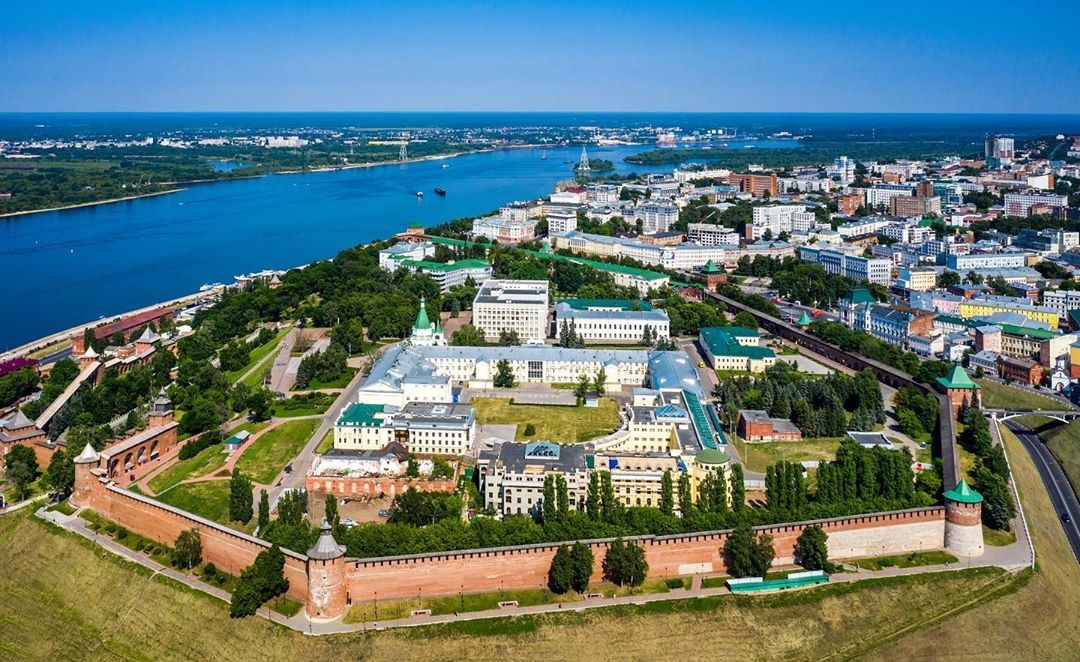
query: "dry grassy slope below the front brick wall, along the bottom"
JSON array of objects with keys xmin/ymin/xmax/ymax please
[{"xmin": 0, "ymin": 503, "xmax": 1024, "ymax": 662}]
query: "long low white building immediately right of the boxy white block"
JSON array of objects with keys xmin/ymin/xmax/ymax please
[{"xmin": 555, "ymin": 299, "xmax": 671, "ymax": 344}]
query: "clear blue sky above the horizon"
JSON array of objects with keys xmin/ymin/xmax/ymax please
[{"xmin": 0, "ymin": 0, "xmax": 1080, "ymax": 113}]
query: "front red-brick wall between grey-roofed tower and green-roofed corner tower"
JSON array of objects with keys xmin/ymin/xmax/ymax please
[{"xmin": 346, "ymin": 506, "xmax": 945, "ymax": 603}]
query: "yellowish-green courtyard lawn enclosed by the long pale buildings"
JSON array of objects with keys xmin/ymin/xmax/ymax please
[{"xmin": 470, "ymin": 397, "xmax": 620, "ymax": 444}]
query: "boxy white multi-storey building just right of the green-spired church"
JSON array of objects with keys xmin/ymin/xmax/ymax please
[{"xmin": 473, "ymin": 279, "xmax": 548, "ymax": 342}]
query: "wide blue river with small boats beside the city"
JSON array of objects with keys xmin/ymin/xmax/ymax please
[{"xmin": 0, "ymin": 143, "xmax": 791, "ymax": 351}]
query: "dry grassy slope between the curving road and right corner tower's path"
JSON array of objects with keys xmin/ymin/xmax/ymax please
[{"xmin": 875, "ymin": 430, "xmax": 1080, "ymax": 660}]
